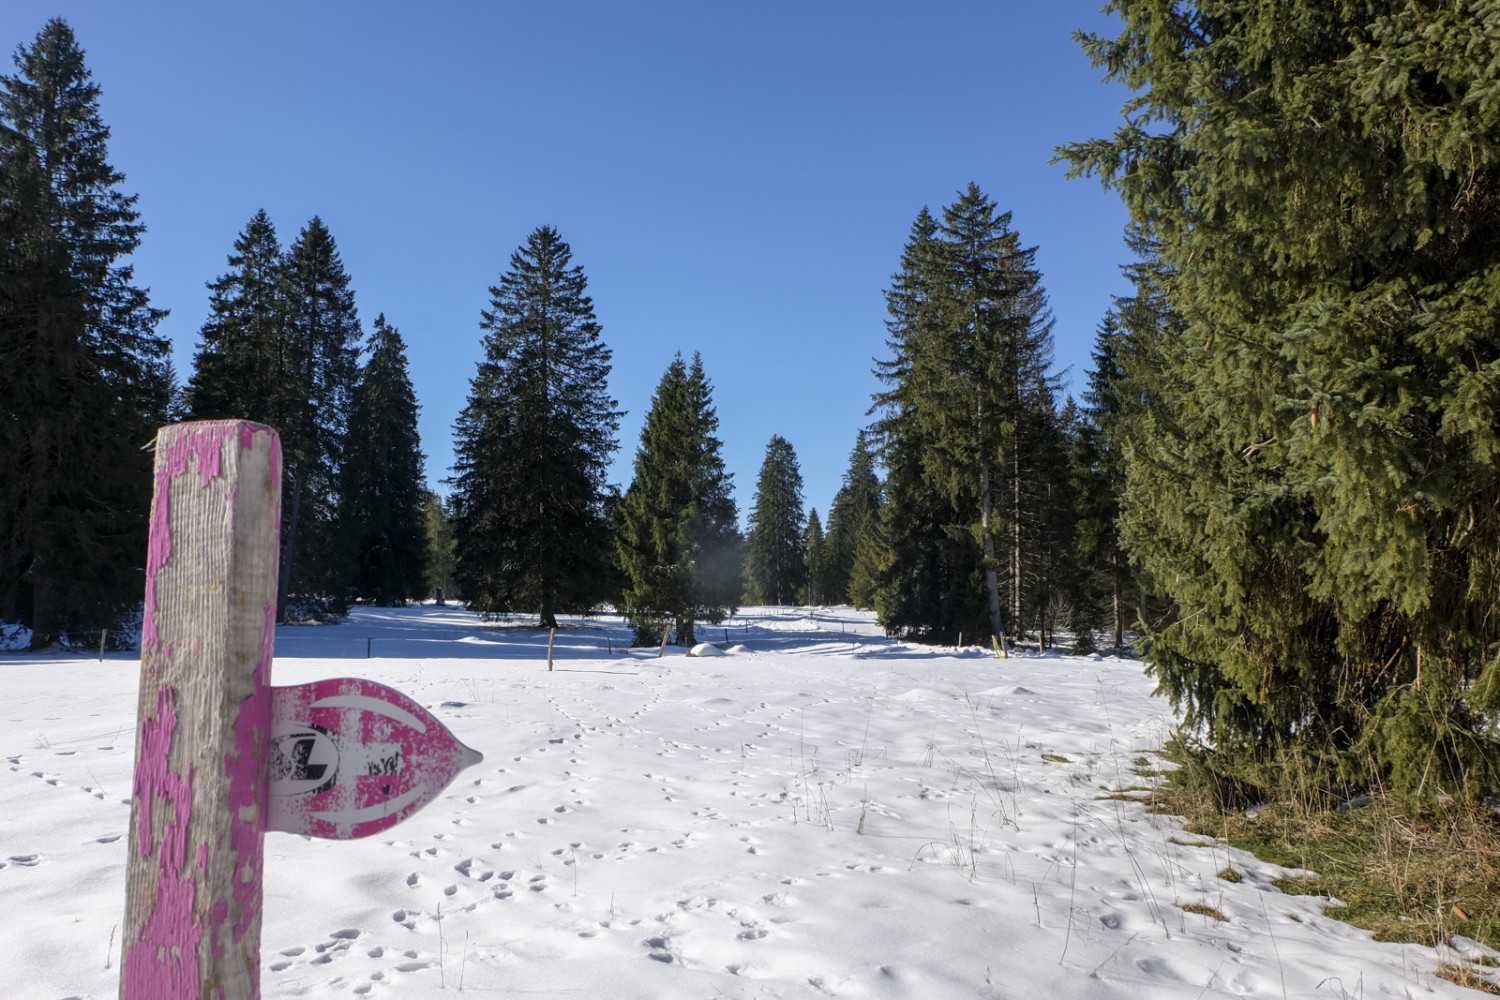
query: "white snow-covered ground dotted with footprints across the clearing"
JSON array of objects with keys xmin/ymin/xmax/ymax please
[{"xmin": 0, "ymin": 606, "xmax": 1494, "ymax": 1000}]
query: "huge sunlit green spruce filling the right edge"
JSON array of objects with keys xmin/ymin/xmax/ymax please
[{"xmin": 1064, "ymin": 0, "xmax": 1500, "ymax": 795}]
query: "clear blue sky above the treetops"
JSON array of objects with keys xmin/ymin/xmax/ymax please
[{"xmin": 0, "ymin": 0, "xmax": 1127, "ymax": 516}]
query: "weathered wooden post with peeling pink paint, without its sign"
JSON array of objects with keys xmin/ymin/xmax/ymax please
[{"xmin": 120, "ymin": 420, "xmax": 281, "ymax": 1000}]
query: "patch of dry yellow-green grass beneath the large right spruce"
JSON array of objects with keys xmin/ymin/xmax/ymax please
[{"xmin": 1152, "ymin": 743, "xmax": 1500, "ymax": 949}]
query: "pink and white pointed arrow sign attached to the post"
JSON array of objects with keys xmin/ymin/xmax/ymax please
[{"xmin": 266, "ymin": 678, "xmax": 485, "ymax": 840}]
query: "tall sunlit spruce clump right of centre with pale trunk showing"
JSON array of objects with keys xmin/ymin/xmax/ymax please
[{"xmin": 876, "ymin": 184, "xmax": 1067, "ymax": 643}]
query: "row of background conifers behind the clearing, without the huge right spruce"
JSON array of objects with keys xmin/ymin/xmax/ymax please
[{"xmin": 0, "ymin": 21, "xmax": 1119, "ymax": 656}]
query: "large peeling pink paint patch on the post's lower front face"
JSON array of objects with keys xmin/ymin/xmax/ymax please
[{"xmin": 123, "ymin": 688, "xmax": 207, "ymax": 997}]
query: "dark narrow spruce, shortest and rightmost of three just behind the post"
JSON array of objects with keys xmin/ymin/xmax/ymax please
[{"xmin": 338, "ymin": 315, "xmax": 428, "ymax": 606}]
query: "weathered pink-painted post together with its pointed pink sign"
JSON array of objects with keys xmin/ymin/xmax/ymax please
[{"xmin": 120, "ymin": 420, "xmax": 482, "ymax": 1000}]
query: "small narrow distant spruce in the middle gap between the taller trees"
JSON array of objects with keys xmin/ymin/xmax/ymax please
[{"xmin": 746, "ymin": 435, "xmax": 821, "ymax": 604}]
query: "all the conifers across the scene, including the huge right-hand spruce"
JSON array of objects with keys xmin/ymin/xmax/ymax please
[{"xmin": 0, "ymin": 7, "xmax": 1500, "ymax": 796}]
